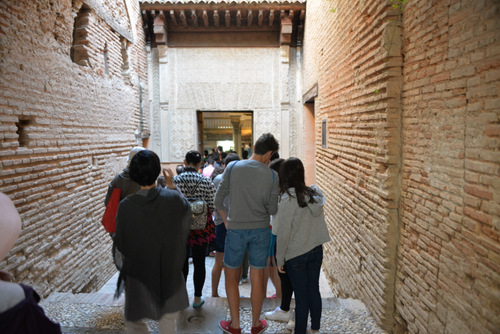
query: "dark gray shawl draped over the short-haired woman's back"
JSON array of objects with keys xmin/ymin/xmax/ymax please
[{"xmin": 114, "ymin": 188, "xmax": 191, "ymax": 304}]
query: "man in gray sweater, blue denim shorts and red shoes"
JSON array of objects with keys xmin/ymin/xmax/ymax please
[{"xmin": 214, "ymin": 133, "xmax": 279, "ymax": 334}]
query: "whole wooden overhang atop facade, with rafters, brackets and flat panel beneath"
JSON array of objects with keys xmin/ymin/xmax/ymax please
[{"xmin": 141, "ymin": 1, "xmax": 305, "ymax": 47}]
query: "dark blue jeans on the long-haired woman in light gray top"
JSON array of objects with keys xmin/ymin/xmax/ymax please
[{"xmin": 285, "ymin": 245, "xmax": 323, "ymax": 334}]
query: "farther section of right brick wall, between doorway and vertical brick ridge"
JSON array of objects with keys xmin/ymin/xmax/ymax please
[{"xmin": 303, "ymin": 1, "xmax": 401, "ymax": 328}]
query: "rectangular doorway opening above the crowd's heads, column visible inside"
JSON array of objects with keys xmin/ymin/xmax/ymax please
[{"xmin": 198, "ymin": 110, "xmax": 253, "ymax": 158}]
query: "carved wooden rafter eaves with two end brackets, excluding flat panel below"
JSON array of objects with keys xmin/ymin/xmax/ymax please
[{"xmin": 141, "ymin": 1, "xmax": 306, "ymax": 46}]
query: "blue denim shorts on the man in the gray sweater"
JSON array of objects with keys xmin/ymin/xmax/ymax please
[{"xmin": 224, "ymin": 227, "xmax": 271, "ymax": 269}]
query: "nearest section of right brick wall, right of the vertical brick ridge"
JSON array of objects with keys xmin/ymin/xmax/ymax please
[{"xmin": 396, "ymin": 0, "xmax": 500, "ymax": 333}]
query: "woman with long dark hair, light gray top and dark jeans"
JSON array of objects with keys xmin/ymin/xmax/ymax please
[{"xmin": 273, "ymin": 158, "xmax": 330, "ymax": 334}]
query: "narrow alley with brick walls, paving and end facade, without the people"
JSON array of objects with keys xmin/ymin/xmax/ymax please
[{"xmin": 0, "ymin": 0, "xmax": 500, "ymax": 334}]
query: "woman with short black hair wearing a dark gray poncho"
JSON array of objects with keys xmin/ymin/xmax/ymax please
[{"xmin": 114, "ymin": 150, "xmax": 191, "ymax": 334}]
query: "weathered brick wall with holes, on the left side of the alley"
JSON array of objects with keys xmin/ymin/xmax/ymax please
[{"xmin": 0, "ymin": 0, "xmax": 147, "ymax": 296}]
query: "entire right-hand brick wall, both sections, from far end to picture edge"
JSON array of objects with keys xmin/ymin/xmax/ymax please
[{"xmin": 303, "ymin": 0, "xmax": 500, "ymax": 333}]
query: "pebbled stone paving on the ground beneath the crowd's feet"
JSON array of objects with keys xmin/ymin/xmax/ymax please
[{"xmin": 41, "ymin": 258, "xmax": 385, "ymax": 334}]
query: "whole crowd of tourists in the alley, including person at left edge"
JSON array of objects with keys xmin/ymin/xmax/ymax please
[{"xmin": 0, "ymin": 133, "xmax": 330, "ymax": 334}]
